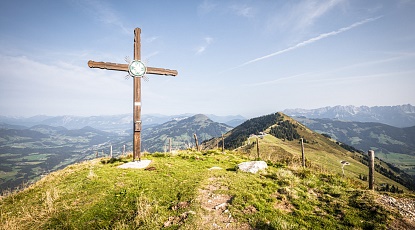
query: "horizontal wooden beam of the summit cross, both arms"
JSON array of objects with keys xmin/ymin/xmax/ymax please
[{"xmin": 88, "ymin": 61, "xmax": 177, "ymax": 76}]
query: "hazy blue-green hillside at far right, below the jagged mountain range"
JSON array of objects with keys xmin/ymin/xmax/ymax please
[{"xmin": 296, "ymin": 118, "xmax": 415, "ymax": 176}]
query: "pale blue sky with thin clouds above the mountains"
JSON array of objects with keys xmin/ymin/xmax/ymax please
[{"xmin": 0, "ymin": 0, "xmax": 415, "ymax": 118}]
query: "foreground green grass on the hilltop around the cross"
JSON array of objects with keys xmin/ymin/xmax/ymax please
[{"xmin": 0, "ymin": 150, "xmax": 410, "ymax": 229}]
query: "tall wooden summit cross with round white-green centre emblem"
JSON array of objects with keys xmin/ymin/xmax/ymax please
[{"xmin": 88, "ymin": 28, "xmax": 177, "ymax": 161}]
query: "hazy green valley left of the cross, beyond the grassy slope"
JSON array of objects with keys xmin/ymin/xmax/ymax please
[{"xmin": 0, "ymin": 126, "xmax": 131, "ymax": 190}]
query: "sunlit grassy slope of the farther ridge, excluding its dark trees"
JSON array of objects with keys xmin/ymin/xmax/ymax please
[{"xmin": 238, "ymin": 127, "xmax": 407, "ymax": 191}]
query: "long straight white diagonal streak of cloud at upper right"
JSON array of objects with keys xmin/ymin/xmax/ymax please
[{"xmin": 233, "ymin": 17, "xmax": 381, "ymax": 69}]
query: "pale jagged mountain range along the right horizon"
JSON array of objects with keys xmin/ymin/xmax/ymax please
[{"xmin": 283, "ymin": 104, "xmax": 415, "ymax": 127}]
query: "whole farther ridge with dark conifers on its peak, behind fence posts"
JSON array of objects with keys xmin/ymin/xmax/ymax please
[{"xmin": 204, "ymin": 113, "xmax": 415, "ymax": 190}]
